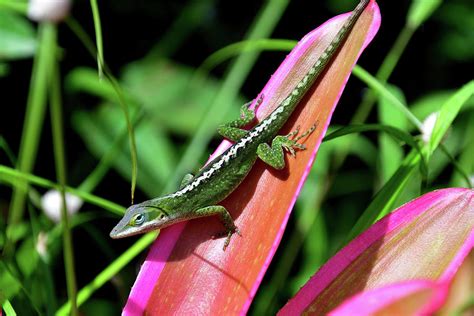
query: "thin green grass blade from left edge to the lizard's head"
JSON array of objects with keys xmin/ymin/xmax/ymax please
[{"xmin": 0, "ymin": 165, "xmax": 125, "ymax": 216}]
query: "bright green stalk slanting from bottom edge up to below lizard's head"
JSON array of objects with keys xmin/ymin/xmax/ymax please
[{"xmin": 56, "ymin": 232, "xmax": 157, "ymax": 316}]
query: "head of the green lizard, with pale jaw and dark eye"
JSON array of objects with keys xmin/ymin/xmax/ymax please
[{"xmin": 110, "ymin": 199, "xmax": 171, "ymax": 239}]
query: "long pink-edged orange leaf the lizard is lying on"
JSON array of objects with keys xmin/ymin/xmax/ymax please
[{"xmin": 124, "ymin": 1, "xmax": 380, "ymax": 315}]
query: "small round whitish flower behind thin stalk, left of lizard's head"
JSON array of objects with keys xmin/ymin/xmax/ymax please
[{"xmin": 41, "ymin": 190, "xmax": 83, "ymax": 223}]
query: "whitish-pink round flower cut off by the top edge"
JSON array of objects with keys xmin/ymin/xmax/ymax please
[{"xmin": 28, "ymin": 0, "xmax": 71, "ymax": 22}]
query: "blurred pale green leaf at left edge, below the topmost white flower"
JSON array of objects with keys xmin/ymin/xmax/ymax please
[{"xmin": 0, "ymin": 10, "xmax": 37, "ymax": 60}]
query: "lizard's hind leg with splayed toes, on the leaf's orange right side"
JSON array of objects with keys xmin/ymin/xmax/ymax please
[{"xmin": 257, "ymin": 125, "xmax": 316, "ymax": 170}]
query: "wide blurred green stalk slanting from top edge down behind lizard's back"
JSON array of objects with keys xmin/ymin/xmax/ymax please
[{"xmin": 165, "ymin": 0, "xmax": 289, "ymax": 191}]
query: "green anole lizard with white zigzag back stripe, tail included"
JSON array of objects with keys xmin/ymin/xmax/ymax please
[{"xmin": 110, "ymin": 0, "xmax": 370, "ymax": 250}]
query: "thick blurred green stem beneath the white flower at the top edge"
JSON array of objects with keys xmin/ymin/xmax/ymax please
[{"xmin": 4, "ymin": 23, "xmax": 56, "ymax": 255}]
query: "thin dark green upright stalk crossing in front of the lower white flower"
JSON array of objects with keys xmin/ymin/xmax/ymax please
[{"xmin": 50, "ymin": 45, "xmax": 78, "ymax": 315}]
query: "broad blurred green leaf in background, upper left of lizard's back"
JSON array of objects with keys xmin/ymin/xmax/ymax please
[{"xmin": 123, "ymin": 59, "xmax": 246, "ymax": 136}]
